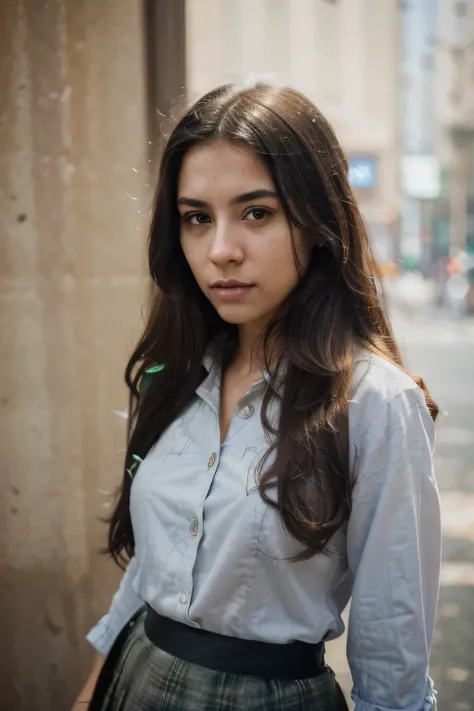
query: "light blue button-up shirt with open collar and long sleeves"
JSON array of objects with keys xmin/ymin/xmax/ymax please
[{"xmin": 88, "ymin": 354, "xmax": 441, "ymax": 711}]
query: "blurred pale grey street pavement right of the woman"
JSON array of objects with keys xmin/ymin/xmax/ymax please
[{"xmin": 328, "ymin": 301, "xmax": 474, "ymax": 711}]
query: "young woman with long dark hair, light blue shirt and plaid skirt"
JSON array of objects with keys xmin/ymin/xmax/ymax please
[{"xmin": 77, "ymin": 85, "xmax": 440, "ymax": 711}]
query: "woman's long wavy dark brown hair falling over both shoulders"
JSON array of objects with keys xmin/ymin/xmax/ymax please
[{"xmin": 108, "ymin": 84, "xmax": 436, "ymax": 564}]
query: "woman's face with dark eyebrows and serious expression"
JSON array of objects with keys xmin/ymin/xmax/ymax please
[{"xmin": 178, "ymin": 141, "xmax": 311, "ymax": 326}]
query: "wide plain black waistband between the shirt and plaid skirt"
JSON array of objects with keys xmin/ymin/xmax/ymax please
[{"xmin": 145, "ymin": 607, "xmax": 326, "ymax": 679}]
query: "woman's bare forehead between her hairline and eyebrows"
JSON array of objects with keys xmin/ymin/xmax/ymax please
[{"xmin": 178, "ymin": 141, "xmax": 275, "ymax": 202}]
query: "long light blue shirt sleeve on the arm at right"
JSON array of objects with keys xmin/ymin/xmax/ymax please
[{"xmin": 347, "ymin": 388, "xmax": 441, "ymax": 711}]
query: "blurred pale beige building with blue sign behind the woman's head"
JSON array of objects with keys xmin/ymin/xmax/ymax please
[{"xmin": 186, "ymin": 0, "xmax": 401, "ymax": 270}]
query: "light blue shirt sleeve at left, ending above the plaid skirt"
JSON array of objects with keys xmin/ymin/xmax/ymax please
[{"xmin": 87, "ymin": 557, "xmax": 145, "ymax": 654}]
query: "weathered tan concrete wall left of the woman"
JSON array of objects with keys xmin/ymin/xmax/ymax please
[{"xmin": 0, "ymin": 0, "xmax": 153, "ymax": 711}]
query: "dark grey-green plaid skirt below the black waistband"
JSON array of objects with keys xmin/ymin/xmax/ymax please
[{"xmin": 89, "ymin": 612, "xmax": 348, "ymax": 711}]
